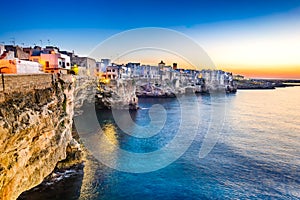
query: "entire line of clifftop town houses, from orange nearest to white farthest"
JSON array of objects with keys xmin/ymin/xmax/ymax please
[{"xmin": 0, "ymin": 45, "xmax": 233, "ymax": 89}]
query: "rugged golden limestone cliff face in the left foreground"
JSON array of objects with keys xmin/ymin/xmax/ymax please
[{"xmin": 0, "ymin": 75, "xmax": 74, "ymax": 200}]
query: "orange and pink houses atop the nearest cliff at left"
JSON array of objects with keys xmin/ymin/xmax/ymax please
[{"xmin": 0, "ymin": 45, "xmax": 96, "ymax": 74}]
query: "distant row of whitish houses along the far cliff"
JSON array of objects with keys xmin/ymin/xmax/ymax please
[{"xmin": 100, "ymin": 59, "xmax": 233, "ymax": 86}]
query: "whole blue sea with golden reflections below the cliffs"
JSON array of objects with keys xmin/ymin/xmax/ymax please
[{"xmin": 20, "ymin": 87, "xmax": 300, "ymax": 200}]
